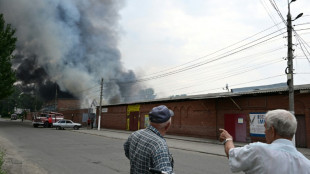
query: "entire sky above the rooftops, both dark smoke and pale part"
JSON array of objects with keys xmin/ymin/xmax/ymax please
[{"xmin": 0, "ymin": 0, "xmax": 310, "ymax": 106}]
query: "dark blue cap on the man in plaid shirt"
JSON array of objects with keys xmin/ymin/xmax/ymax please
[{"xmin": 149, "ymin": 105, "xmax": 174, "ymax": 123}]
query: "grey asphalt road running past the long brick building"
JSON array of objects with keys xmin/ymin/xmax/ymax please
[{"xmin": 0, "ymin": 120, "xmax": 235, "ymax": 174}]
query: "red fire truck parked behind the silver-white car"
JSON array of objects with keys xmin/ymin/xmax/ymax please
[{"xmin": 32, "ymin": 112, "xmax": 64, "ymax": 127}]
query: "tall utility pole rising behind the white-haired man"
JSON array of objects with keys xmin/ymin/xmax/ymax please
[{"xmin": 286, "ymin": 3, "xmax": 295, "ymax": 114}]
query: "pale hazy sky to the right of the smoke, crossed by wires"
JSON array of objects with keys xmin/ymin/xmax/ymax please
[{"xmin": 118, "ymin": 0, "xmax": 310, "ymax": 98}]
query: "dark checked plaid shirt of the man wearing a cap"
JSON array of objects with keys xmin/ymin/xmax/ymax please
[{"xmin": 124, "ymin": 126, "xmax": 173, "ymax": 174}]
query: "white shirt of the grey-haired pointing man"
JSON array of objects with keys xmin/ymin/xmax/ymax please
[{"xmin": 229, "ymin": 139, "xmax": 310, "ymax": 174}]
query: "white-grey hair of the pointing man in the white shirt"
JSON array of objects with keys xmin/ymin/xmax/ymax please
[{"xmin": 265, "ymin": 109, "xmax": 297, "ymax": 138}]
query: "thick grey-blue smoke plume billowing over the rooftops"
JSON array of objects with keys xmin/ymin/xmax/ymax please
[{"xmin": 0, "ymin": 0, "xmax": 151, "ymax": 103}]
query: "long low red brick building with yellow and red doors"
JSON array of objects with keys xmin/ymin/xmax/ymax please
[{"xmin": 97, "ymin": 85, "xmax": 310, "ymax": 148}]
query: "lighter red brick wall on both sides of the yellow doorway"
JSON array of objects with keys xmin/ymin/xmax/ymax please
[{"xmin": 101, "ymin": 100, "xmax": 216, "ymax": 138}]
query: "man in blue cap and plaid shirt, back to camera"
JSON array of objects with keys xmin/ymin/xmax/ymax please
[{"xmin": 124, "ymin": 105, "xmax": 174, "ymax": 174}]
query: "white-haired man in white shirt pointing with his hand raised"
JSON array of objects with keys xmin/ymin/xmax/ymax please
[{"xmin": 220, "ymin": 109, "xmax": 310, "ymax": 174}]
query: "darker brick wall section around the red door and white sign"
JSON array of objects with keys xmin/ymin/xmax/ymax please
[{"xmin": 216, "ymin": 93, "xmax": 310, "ymax": 148}]
